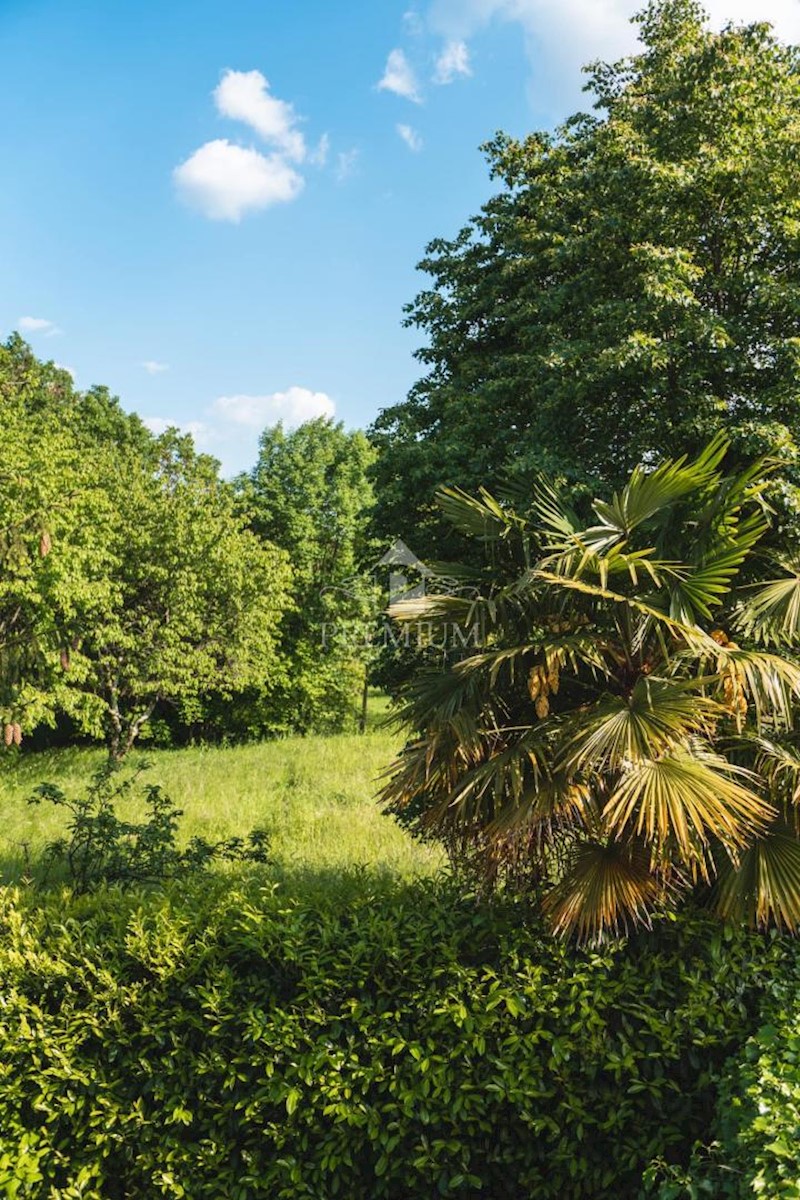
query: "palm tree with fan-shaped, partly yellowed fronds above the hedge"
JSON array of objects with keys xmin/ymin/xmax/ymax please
[{"xmin": 383, "ymin": 437, "xmax": 800, "ymax": 938}]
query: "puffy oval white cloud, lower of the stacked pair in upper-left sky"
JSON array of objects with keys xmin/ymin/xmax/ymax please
[{"xmin": 173, "ymin": 138, "xmax": 303, "ymax": 221}]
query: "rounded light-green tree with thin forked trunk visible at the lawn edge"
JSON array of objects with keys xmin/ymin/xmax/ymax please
[{"xmin": 58, "ymin": 431, "xmax": 290, "ymax": 758}]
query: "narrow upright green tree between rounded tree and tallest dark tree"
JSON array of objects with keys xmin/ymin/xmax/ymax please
[{"xmin": 240, "ymin": 418, "xmax": 374, "ymax": 731}]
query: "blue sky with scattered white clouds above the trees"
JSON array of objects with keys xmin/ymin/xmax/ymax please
[{"xmin": 0, "ymin": 0, "xmax": 800, "ymax": 472}]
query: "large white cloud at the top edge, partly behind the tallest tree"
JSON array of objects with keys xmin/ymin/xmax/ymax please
[{"xmin": 428, "ymin": 0, "xmax": 800, "ymax": 94}]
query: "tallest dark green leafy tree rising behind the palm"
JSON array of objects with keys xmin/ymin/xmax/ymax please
[{"xmin": 373, "ymin": 0, "xmax": 800, "ymax": 554}]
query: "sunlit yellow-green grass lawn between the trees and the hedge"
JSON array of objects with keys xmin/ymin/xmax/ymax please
[{"xmin": 0, "ymin": 715, "xmax": 440, "ymax": 882}]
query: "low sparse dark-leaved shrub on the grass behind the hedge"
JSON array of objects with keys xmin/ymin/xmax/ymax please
[{"xmin": 29, "ymin": 762, "xmax": 267, "ymax": 893}]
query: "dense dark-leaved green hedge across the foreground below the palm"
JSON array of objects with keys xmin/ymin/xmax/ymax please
[{"xmin": 0, "ymin": 875, "xmax": 786, "ymax": 1200}]
